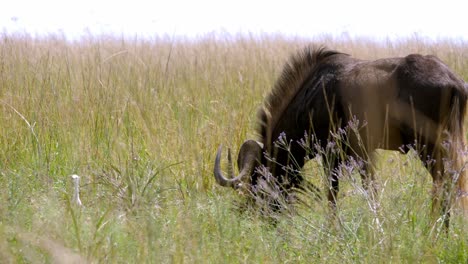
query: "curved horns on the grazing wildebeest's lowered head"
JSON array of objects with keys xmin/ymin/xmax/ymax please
[{"xmin": 214, "ymin": 140, "xmax": 262, "ymax": 188}]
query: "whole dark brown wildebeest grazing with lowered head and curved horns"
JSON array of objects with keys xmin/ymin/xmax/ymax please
[{"xmin": 214, "ymin": 47, "xmax": 468, "ymax": 225}]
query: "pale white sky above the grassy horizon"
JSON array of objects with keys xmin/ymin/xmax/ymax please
[{"xmin": 0, "ymin": 0, "xmax": 468, "ymax": 41}]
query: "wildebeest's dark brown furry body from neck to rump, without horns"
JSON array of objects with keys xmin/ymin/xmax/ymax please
[{"xmin": 251, "ymin": 47, "xmax": 467, "ymax": 221}]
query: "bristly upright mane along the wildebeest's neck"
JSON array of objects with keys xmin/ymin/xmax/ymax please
[{"xmin": 258, "ymin": 46, "xmax": 342, "ymax": 147}]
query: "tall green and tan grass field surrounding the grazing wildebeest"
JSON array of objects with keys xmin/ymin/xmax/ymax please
[{"xmin": 0, "ymin": 35, "xmax": 468, "ymax": 263}]
